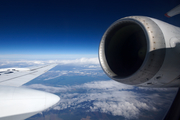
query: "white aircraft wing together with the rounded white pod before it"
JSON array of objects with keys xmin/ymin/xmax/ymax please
[{"xmin": 0, "ymin": 64, "xmax": 60, "ymax": 120}]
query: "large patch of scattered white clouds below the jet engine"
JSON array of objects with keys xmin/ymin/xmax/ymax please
[{"xmin": 23, "ymin": 80, "xmax": 176, "ymax": 119}]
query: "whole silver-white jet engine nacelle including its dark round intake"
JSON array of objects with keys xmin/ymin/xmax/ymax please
[{"xmin": 99, "ymin": 16, "xmax": 180, "ymax": 87}]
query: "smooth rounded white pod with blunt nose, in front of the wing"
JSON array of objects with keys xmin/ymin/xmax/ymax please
[{"xmin": 0, "ymin": 86, "xmax": 60, "ymax": 120}]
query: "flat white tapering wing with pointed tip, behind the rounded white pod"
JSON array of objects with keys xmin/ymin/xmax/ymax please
[{"xmin": 0, "ymin": 64, "xmax": 57, "ymax": 87}]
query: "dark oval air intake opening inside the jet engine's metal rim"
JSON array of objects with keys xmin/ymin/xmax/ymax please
[{"xmin": 105, "ymin": 21, "xmax": 147, "ymax": 78}]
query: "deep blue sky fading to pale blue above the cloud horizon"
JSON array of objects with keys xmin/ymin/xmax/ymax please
[{"xmin": 0, "ymin": 0, "xmax": 180, "ymax": 54}]
